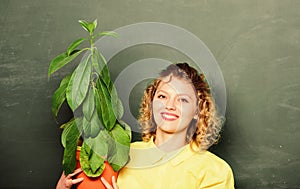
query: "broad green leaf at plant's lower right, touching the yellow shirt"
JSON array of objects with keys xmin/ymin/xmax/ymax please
[{"xmin": 108, "ymin": 123, "xmax": 131, "ymax": 171}]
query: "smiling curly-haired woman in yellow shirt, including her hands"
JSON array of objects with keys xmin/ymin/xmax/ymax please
[{"xmin": 58, "ymin": 63, "xmax": 234, "ymax": 189}]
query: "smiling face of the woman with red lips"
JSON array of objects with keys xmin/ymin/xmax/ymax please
[{"xmin": 152, "ymin": 76, "xmax": 197, "ymax": 134}]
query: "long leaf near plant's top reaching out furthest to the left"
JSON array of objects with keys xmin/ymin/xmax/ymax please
[{"xmin": 48, "ymin": 49, "xmax": 87, "ymax": 79}]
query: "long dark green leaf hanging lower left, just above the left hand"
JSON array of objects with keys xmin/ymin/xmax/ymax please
[{"xmin": 62, "ymin": 120, "xmax": 80, "ymax": 175}]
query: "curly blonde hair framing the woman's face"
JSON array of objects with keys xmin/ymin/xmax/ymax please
[{"xmin": 138, "ymin": 63, "xmax": 224, "ymax": 150}]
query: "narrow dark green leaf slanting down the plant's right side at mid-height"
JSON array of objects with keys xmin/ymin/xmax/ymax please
[{"xmin": 96, "ymin": 79, "xmax": 116, "ymax": 130}]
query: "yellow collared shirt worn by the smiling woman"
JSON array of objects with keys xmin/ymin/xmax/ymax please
[{"xmin": 117, "ymin": 140, "xmax": 234, "ymax": 189}]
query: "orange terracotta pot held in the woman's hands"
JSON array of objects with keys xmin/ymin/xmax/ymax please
[{"xmin": 76, "ymin": 150, "xmax": 118, "ymax": 189}]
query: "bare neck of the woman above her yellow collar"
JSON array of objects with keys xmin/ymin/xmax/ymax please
[{"xmin": 154, "ymin": 130, "xmax": 187, "ymax": 152}]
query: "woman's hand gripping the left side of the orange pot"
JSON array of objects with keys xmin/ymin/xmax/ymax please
[{"xmin": 56, "ymin": 168, "xmax": 83, "ymax": 189}]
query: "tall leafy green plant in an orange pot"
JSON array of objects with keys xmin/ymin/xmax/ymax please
[{"xmin": 48, "ymin": 20, "xmax": 131, "ymax": 189}]
